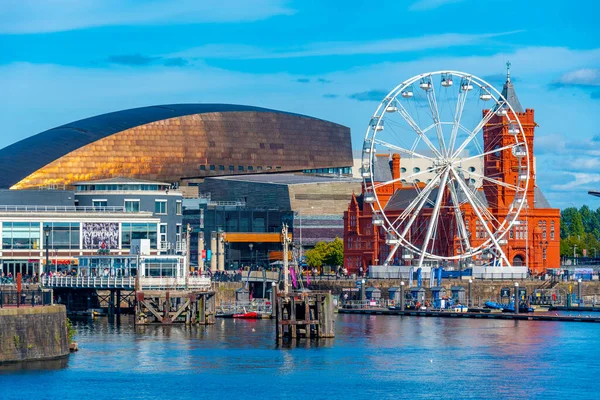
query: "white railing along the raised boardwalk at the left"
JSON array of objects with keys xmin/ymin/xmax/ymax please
[{"xmin": 42, "ymin": 276, "xmax": 211, "ymax": 290}]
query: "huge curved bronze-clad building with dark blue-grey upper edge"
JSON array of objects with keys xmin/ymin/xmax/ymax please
[{"xmin": 0, "ymin": 104, "xmax": 352, "ymax": 189}]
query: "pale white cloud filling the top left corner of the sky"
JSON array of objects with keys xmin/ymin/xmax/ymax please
[{"xmin": 0, "ymin": 0, "xmax": 294, "ymax": 34}]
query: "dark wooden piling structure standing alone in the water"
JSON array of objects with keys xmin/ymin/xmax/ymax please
[{"xmin": 274, "ymin": 291, "xmax": 335, "ymax": 340}]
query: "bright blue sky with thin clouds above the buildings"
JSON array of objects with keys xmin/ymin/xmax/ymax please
[{"xmin": 0, "ymin": 0, "xmax": 600, "ymax": 208}]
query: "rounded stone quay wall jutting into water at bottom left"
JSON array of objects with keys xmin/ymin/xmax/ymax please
[{"xmin": 0, "ymin": 305, "xmax": 69, "ymax": 363}]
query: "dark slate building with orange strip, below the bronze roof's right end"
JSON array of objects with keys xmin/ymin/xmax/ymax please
[{"xmin": 190, "ymin": 173, "xmax": 361, "ymax": 266}]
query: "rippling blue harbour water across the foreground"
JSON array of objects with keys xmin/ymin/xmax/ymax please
[{"xmin": 0, "ymin": 315, "xmax": 598, "ymax": 400}]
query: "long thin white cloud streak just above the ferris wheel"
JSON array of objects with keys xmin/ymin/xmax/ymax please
[{"xmin": 169, "ymin": 31, "xmax": 521, "ymax": 59}]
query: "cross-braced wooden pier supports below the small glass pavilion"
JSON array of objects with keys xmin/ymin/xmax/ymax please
[{"xmin": 135, "ymin": 290, "xmax": 216, "ymax": 325}]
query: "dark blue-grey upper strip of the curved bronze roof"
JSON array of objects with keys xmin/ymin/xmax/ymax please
[{"xmin": 0, "ymin": 104, "xmax": 315, "ymax": 188}]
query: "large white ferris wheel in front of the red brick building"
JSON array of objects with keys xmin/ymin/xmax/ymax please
[{"xmin": 361, "ymin": 71, "xmax": 530, "ymax": 266}]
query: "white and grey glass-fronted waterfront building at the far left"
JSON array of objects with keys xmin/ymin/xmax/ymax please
[{"xmin": 0, "ymin": 178, "xmax": 184, "ymax": 276}]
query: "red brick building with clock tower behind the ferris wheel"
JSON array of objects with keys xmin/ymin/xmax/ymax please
[{"xmin": 344, "ymin": 74, "xmax": 560, "ymax": 274}]
